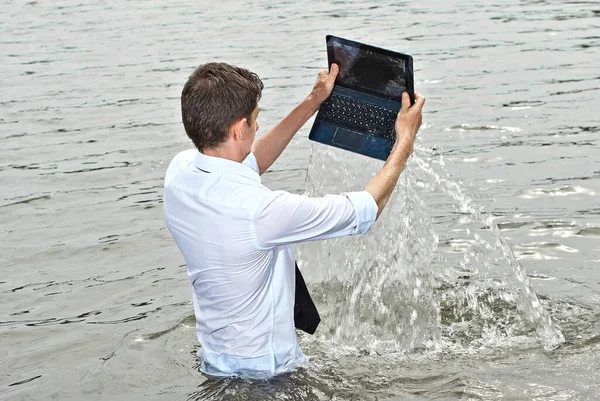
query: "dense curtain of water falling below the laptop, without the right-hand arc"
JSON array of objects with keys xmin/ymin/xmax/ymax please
[{"xmin": 299, "ymin": 146, "xmax": 440, "ymax": 350}]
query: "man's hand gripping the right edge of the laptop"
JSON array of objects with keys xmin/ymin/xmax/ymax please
[{"xmin": 392, "ymin": 92, "xmax": 425, "ymax": 159}]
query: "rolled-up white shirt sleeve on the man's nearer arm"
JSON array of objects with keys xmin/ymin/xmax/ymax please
[{"xmin": 254, "ymin": 191, "xmax": 377, "ymax": 249}]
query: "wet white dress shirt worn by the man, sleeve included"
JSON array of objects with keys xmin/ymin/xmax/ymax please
[{"xmin": 164, "ymin": 149, "xmax": 377, "ymax": 376}]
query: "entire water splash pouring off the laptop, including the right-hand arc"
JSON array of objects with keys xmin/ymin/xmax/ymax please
[{"xmin": 299, "ymin": 141, "xmax": 564, "ymax": 352}]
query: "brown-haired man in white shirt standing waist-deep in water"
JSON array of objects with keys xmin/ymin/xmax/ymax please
[{"xmin": 164, "ymin": 63, "xmax": 425, "ymax": 376}]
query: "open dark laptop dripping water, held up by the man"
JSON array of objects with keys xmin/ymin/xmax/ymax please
[{"xmin": 308, "ymin": 35, "xmax": 415, "ymax": 160}]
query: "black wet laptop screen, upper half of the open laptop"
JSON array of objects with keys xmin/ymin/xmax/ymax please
[{"xmin": 327, "ymin": 36, "xmax": 413, "ymax": 100}]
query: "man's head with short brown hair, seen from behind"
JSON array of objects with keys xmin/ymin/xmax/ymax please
[{"xmin": 181, "ymin": 63, "xmax": 263, "ymax": 156}]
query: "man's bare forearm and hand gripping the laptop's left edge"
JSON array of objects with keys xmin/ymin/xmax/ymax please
[{"xmin": 252, "ymin": 64, "xmax": 339, "ymax": 174}]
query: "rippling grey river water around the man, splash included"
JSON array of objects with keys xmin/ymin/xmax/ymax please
[{"xmin": 0, "ymin": 0, "xmax": 600, "ymax": 400}]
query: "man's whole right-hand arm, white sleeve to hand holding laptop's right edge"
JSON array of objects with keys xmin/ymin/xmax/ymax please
[{"xmin": 254, "ymin": 93, "xmax": 425, "ymax": 249}]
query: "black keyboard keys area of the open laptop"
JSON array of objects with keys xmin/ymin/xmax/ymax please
[{"xmin": 319, "ymin": 95, "xmax": 397, "ymax": 139}]
